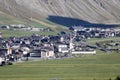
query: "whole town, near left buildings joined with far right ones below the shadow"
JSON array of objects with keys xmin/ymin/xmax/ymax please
[{"xmin": 0, "ymin": 27, "xmax": 120, "ymax": 65}]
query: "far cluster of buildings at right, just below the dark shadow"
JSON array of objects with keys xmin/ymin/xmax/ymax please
[{"xmin": 70, "ymin": 26, "xmax": 120, "ymax": 38}]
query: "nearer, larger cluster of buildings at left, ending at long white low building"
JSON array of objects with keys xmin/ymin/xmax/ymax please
[{"xmin": 0, "ymin": 32, "xmax": 96, "ymax": 65}]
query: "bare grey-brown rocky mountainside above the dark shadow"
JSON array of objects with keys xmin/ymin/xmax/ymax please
[{"xmin": 0, "ymin": 0, "xmax": 120, "ymax": 24}]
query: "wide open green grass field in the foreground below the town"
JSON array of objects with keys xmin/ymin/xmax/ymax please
[{"xmin": 0, "ymin": 53, "xmax": 120, "ymax": 80}]
